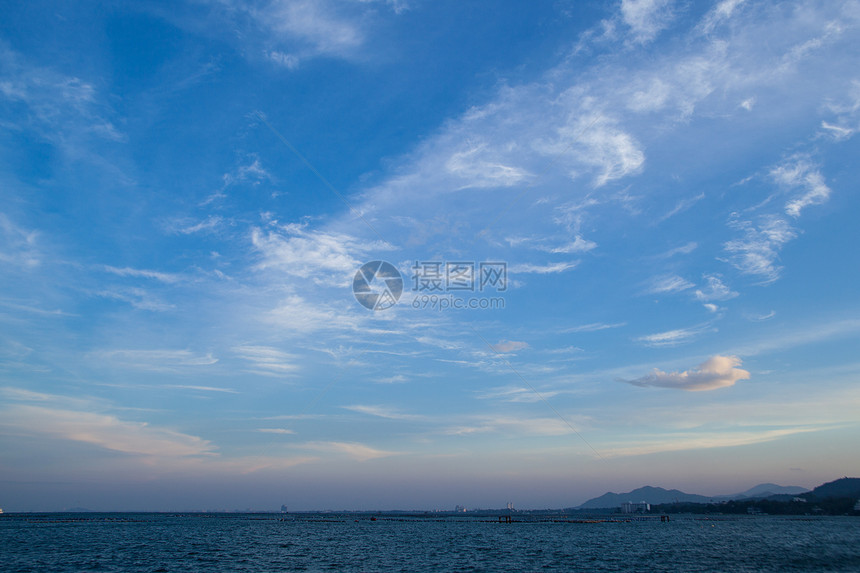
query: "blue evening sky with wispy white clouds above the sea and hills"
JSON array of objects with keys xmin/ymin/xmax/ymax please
[{"xmin": 0, "ymin": 0, "xmax": 860, "ymax": 511}]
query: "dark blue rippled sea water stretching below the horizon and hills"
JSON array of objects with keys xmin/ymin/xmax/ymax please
[{"xmin": 0, "ymin": 513, "xmax": 860, "ymax": 573}]
